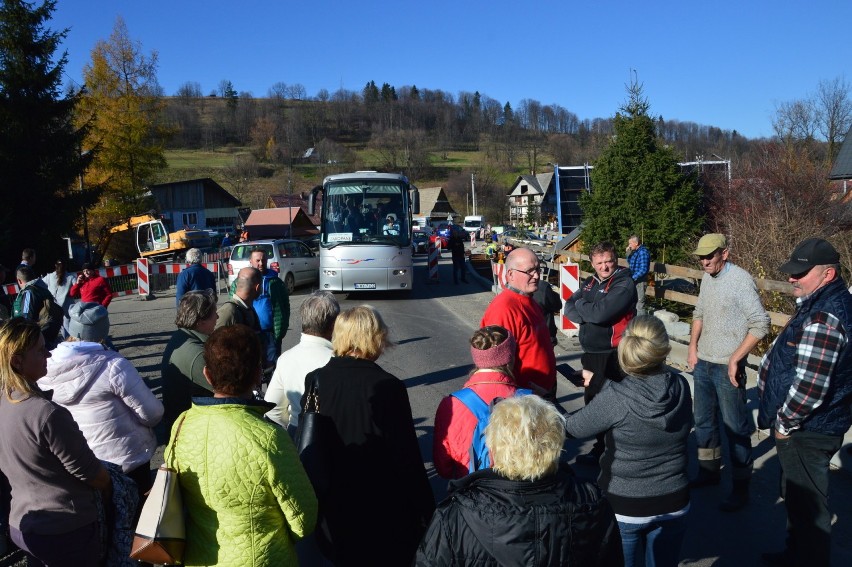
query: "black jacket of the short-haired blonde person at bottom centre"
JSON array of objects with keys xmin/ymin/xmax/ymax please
[{"xmin": 415, "ymin": 465, "xmax": 624, "ymax": 567}]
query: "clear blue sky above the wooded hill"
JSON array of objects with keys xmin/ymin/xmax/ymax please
[{"xmin": 50, "ymin": 0, "xmax": 852, "ymax": 138}]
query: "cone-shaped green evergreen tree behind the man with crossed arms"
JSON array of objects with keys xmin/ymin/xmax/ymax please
[{"xmin": 580, "ymin": 82, "xmax": 703, "ymax": 263}]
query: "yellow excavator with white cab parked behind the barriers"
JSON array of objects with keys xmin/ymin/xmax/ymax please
[{"xmin": 94, "ymin": 213, "xmax": 211, "ymax": 264}]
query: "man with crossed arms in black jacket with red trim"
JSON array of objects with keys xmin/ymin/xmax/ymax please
[{"xmin": 565, "ymin": 242, "xmax": 636, "ymax": 466}]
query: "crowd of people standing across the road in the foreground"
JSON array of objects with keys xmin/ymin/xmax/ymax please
[{"xmin": 0, "ymin": 234, "xmax": 852, "ymax": 567}]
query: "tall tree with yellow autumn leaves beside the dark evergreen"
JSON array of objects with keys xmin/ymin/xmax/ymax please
[{"xmin": 78, "ymin": 16, "xmax": 170, "ymax": 232}]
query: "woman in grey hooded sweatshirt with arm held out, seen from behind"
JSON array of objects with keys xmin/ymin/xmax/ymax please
[{"xmin": 565, "ymin": 315, "xmax": 693, "ymax": 567}]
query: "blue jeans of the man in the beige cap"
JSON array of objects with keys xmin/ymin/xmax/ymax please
[{"xmin": 692, "ymin": 360, "xmax": 754, "ymax": 475}]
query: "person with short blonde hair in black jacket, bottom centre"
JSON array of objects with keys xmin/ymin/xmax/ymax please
[{"xmin": 416, "ymin": 395, "xmax": 624, "ymax": 567}]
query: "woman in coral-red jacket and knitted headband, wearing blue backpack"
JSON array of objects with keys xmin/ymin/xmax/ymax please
[{"xmin": 432, "ymin": 325, "xmax": 518, "ymax": 479}]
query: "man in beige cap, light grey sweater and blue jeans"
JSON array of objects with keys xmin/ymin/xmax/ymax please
[{"xmin": 686, "ymin": 234, "xmax": 769, "ymax": 512}]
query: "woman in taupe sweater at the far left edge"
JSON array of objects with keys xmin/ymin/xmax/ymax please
[{"xmin": 0, "ymin": 317, "xmax": 112, "ymax": 566}]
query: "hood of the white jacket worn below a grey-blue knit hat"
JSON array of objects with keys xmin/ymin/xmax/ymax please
[{"xmin": 38, "ymin": 341, "xmax": 119, "ymax": 405}]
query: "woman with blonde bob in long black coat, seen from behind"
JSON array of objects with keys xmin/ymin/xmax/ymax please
[{"xmin": 299, "ymin": 305, "xmax": 435, "ymax": 566}]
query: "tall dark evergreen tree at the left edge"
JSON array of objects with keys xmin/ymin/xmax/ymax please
[{"xmin": 0, "ymin": 0, "xmax": 97, "ymax": 266}]
